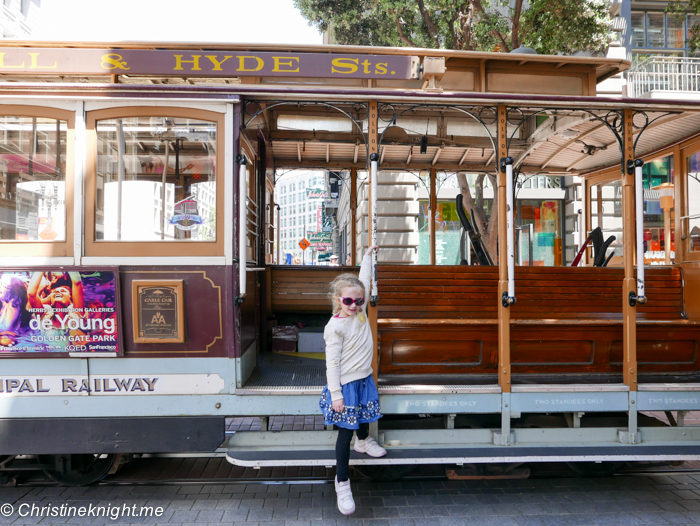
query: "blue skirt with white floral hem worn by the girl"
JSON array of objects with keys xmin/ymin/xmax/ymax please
[{"xmin": 318, "ymin": 374, "xmax": 382, "ymax": 429}]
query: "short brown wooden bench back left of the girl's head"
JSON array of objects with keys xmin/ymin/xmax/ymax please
[{"xmin": 268, "ymin": 265, "xmax": 359, "ymax": 315}]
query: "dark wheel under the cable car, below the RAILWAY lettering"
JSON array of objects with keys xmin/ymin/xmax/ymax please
[{"xmin": 37, "ymin": 454, "xmax": 117, "ymax": 486}]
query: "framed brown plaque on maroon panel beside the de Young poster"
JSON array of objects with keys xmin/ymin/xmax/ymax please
[{"xmin": 131, "ymin": 279, "xmax": 185, "ymax": 343}]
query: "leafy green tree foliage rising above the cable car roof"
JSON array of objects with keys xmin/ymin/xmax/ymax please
[{"xmin": 294, "ymin": 0, "xmax": 612, "ymax": 54}]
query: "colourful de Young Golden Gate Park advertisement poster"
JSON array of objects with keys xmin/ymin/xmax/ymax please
[{"xmin": 0, "ymin": 269, "xmax": 121, "ymax": 357}]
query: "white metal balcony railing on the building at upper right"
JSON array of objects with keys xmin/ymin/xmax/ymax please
[{"xmin": 627, "ymin": 55, "xmax": 700, "ymax": 97}]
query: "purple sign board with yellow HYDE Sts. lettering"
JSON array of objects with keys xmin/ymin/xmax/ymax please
[{"xmin": 0, "ymin": 47, "xmax": 419, "ymax": 79}]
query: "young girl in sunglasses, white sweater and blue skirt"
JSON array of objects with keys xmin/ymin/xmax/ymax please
[{"xmin": 319, "ymin": 247, "xmax": 386, "ymax": 515}]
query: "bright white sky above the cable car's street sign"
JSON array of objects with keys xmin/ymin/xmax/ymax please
[{"xmin": 31, "ymin": 0, "xmax": 323, "ymax": 44}]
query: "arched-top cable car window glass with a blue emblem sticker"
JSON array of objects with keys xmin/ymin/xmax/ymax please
[{"xmin": 95, "ymin": 117, "xmax": 217, "ymax": 241}]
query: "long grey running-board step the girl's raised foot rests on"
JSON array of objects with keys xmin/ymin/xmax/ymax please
[{"xmin": 226, "ymin": 428, "xmax": 700, "ymax": 467}]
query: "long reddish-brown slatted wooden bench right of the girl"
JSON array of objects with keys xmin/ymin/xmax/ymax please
[{"xmin": 378, "ymin": 265, "xmax": 700, "ymax": 375}]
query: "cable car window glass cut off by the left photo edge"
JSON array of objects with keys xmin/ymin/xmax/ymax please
[{"xmin": 0, "ymin": 116, "xmax": 68, "ymax": 242}]
